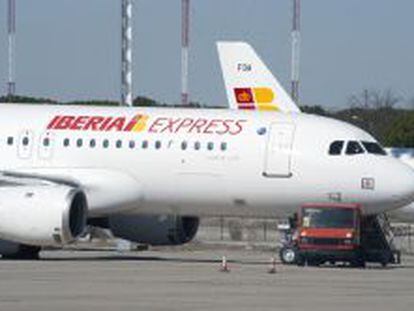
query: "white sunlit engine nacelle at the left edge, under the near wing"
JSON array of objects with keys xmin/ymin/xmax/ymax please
[{"xmin": 0, "ymin": 184, "xmax": 88, "ymax": 246}]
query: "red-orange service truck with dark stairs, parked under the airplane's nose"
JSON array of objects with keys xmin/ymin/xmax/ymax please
[{"xmin": 280, "ymin": 203, "xmax": 399, "ymax": 267}]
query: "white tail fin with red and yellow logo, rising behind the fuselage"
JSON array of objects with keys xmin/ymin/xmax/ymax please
[{"xmin": 217, "ymin": 42, "xmax": 300, "ymax": 112}]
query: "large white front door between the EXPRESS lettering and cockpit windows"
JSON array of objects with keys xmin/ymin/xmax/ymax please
[{"xmin": 263, "ymin": 123, "xmax": 295, "ymax": 178}]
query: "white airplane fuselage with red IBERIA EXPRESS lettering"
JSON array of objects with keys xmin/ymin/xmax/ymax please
[{"xmin": 0, "ymin": 105, "xmax": 414, "ymax": 217}]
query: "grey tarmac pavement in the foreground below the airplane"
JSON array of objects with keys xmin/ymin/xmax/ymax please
[{"xmin": 0, "ymin": 249, "xmax": 414, "ymax": 311}]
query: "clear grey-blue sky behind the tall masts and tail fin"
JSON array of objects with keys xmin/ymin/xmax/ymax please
[{"xmin": 0, "ymin": 0, "xmax": 414, "ymax": 108}]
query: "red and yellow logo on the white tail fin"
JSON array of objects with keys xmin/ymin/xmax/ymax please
[{"xmin": 234, "ymin": 87, "xmax": 279, "ymax": 111}]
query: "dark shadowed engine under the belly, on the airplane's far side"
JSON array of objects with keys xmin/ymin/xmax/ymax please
[{"xmin": 108, "ymin": 215, "xmax": 199, "ymax": 246}]
